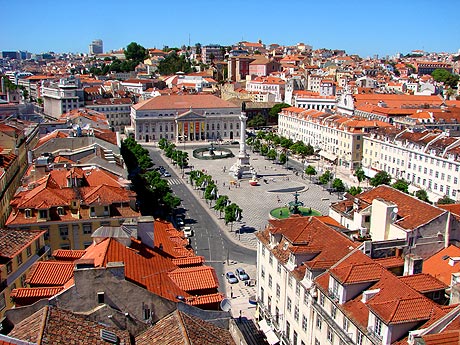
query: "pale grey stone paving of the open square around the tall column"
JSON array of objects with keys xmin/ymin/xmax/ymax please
[{"xmin": 167, "ymin": 146, "xmax": 344, "ymax": 249}]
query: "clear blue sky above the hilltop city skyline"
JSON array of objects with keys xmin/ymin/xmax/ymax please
[{"xmin": 0, "ymin": 0, "xmax": 460, "ymax": 57}]
